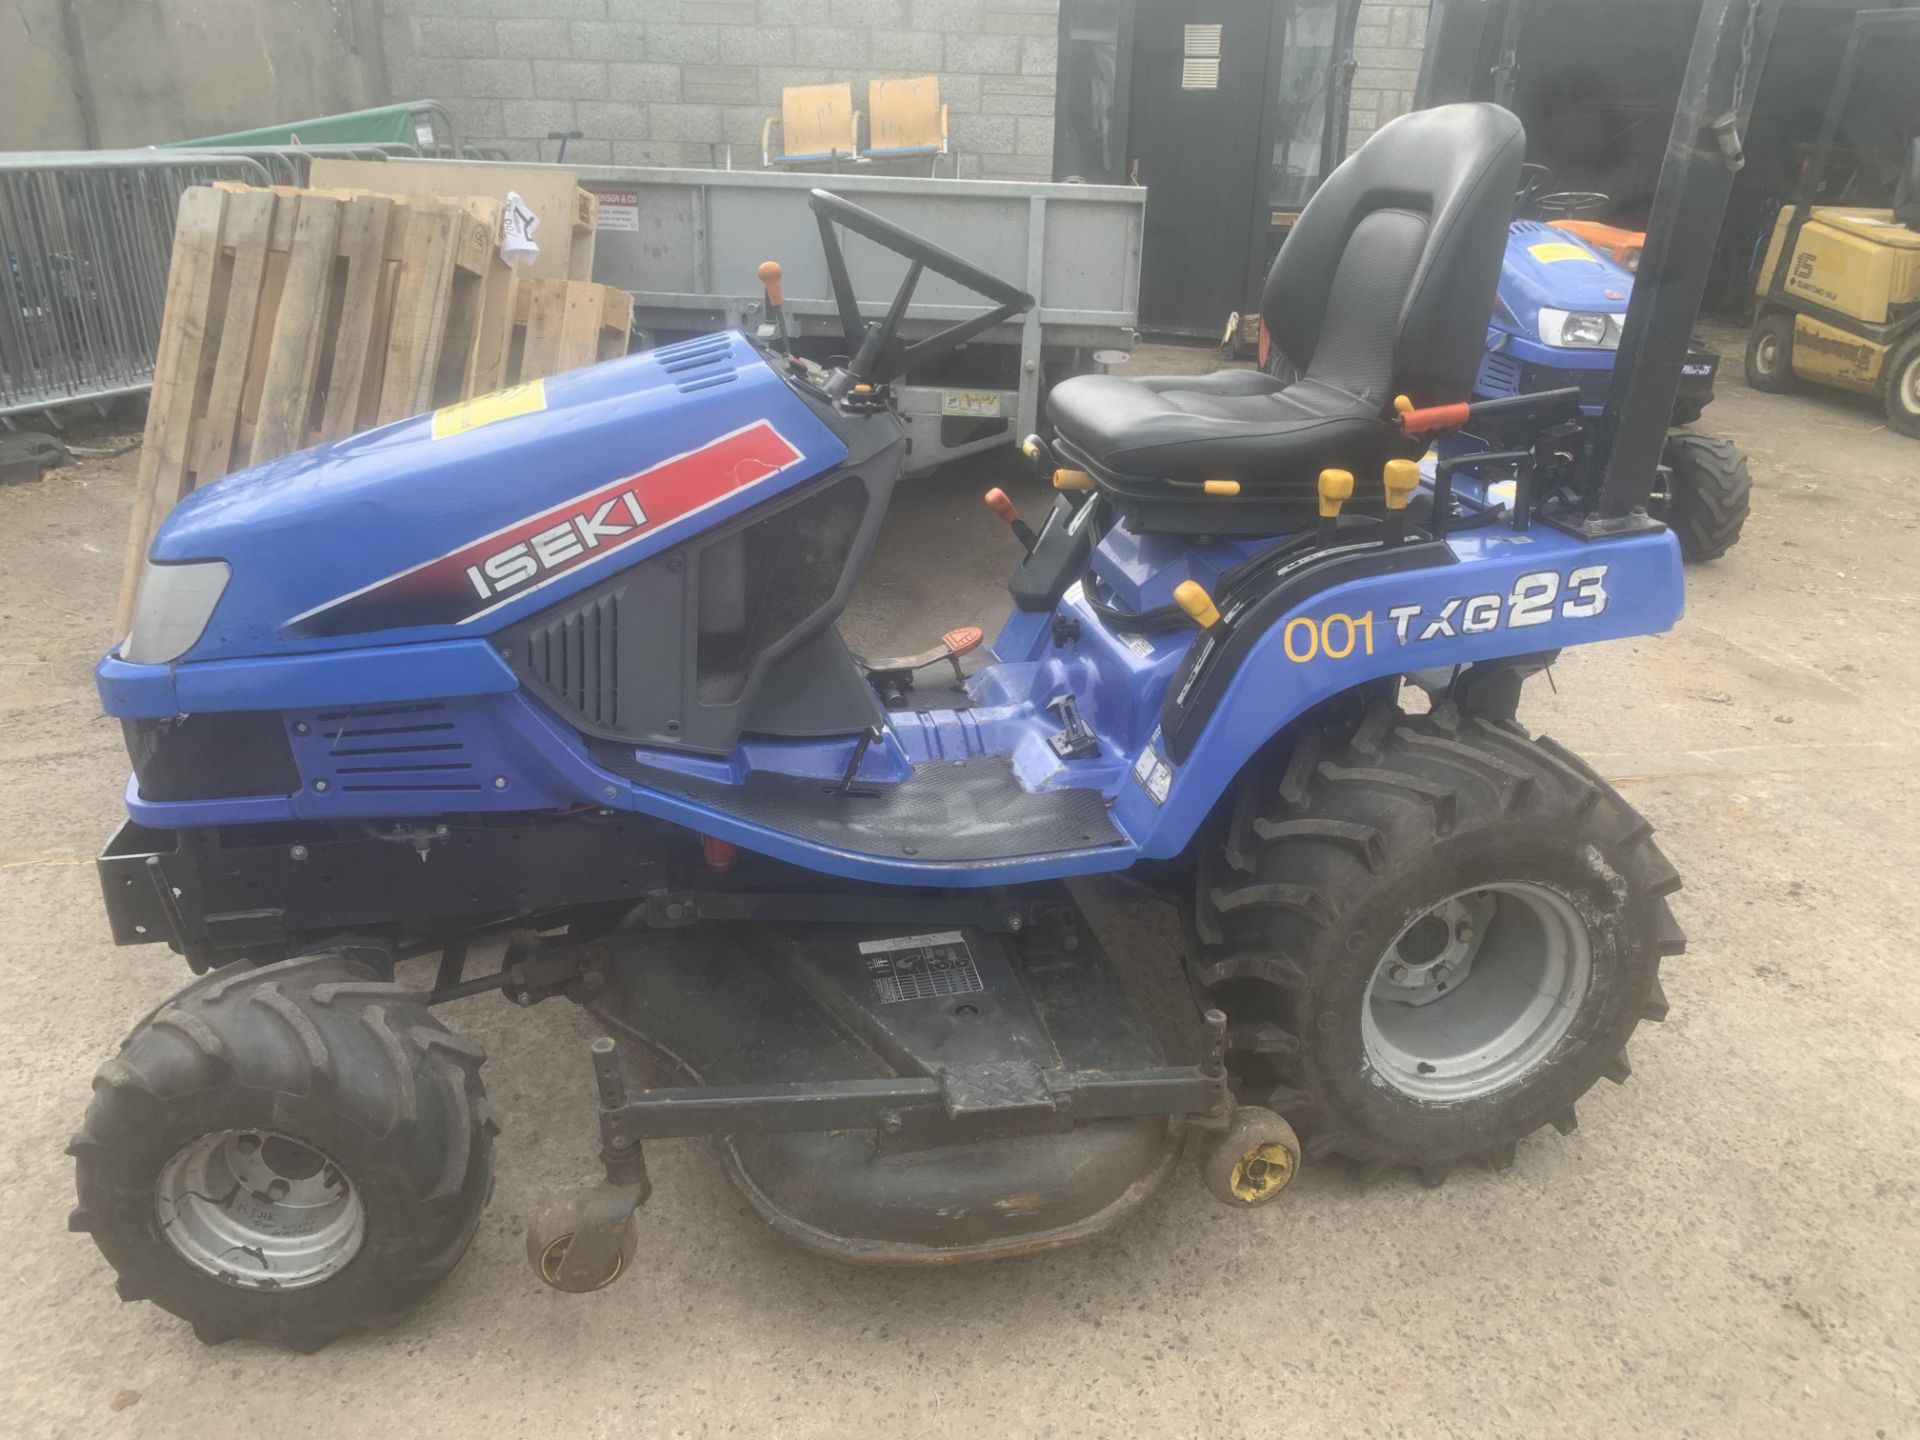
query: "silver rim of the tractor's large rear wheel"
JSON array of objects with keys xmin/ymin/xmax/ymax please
[{"xmin": 1359, "ymin": 881, "xmax": 1594, "ymax": 1102}]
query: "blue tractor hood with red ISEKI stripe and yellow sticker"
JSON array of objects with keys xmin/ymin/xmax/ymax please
[{"xmin": 125, "ymin": 334, "xmax": 847, "ymax": 660}]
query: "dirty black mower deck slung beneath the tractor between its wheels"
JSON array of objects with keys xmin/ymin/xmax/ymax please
[{"xmin": 582, "ymin": 887, "xmax": 1231, "ymax": 1265}]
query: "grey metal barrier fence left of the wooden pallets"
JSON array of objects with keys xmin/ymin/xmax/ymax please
[{"xmin": 0, "ymin": 150, "xmax": 273, "ymax": 417}]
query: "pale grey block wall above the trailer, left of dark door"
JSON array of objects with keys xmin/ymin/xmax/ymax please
[{"xmin": 382, "ymin": 0, "xmax": 1060, "ymax": 179}]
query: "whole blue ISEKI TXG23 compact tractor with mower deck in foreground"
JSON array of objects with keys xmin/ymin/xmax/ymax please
[{"xmin": 71, "ymin": 104, "xmax": 1684, "ymax": 1348}]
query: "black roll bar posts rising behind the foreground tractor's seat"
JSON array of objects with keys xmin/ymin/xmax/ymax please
[{"xmin": 1415, "ymin": 0, "xmax": 1780, "ymax": 514}]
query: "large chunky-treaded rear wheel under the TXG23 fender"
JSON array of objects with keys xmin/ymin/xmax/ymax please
[{"xmin": 1192, "ymin": 703, "xmax": 1684, "ymax": 1183}]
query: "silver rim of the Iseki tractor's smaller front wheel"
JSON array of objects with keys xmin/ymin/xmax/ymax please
[{"xmin": 154, "ymin": 1131, "xmax": 367, "ymax": 1290}]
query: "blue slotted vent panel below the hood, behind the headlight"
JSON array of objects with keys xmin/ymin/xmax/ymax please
[{"xmin": 286, "ymin": 701, "xmax": 484, "ymax": 795}]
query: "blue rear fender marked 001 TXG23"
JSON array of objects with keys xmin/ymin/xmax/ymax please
[{"xmin": 1114, "ymin": 526, "xmax": 1684, "ymax": 858}]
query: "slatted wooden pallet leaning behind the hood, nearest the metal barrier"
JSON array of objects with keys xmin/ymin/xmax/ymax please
[{"xmin": 115, "ymin": 186, "xmax": 495, "ymax": 636}]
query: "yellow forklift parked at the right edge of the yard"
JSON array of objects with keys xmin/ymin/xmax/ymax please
[{"xmin": 1747, "ymin": 10, "xmax": 1920, "ymax": 440}]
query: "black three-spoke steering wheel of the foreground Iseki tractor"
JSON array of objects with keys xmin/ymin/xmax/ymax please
[{"xmin": 810, "ymin": 190, "xmax": 1033, "ymax": 396}]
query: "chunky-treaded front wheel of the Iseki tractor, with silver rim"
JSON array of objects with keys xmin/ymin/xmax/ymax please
[{"xmin": 69, "ymin": 954, "xmax": 495, "ymax": 1350}]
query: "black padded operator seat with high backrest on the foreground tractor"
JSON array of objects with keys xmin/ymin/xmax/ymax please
[{"xmin": 1046, "ymin": 104, "xmax": 1526, "ymax": 534}]
